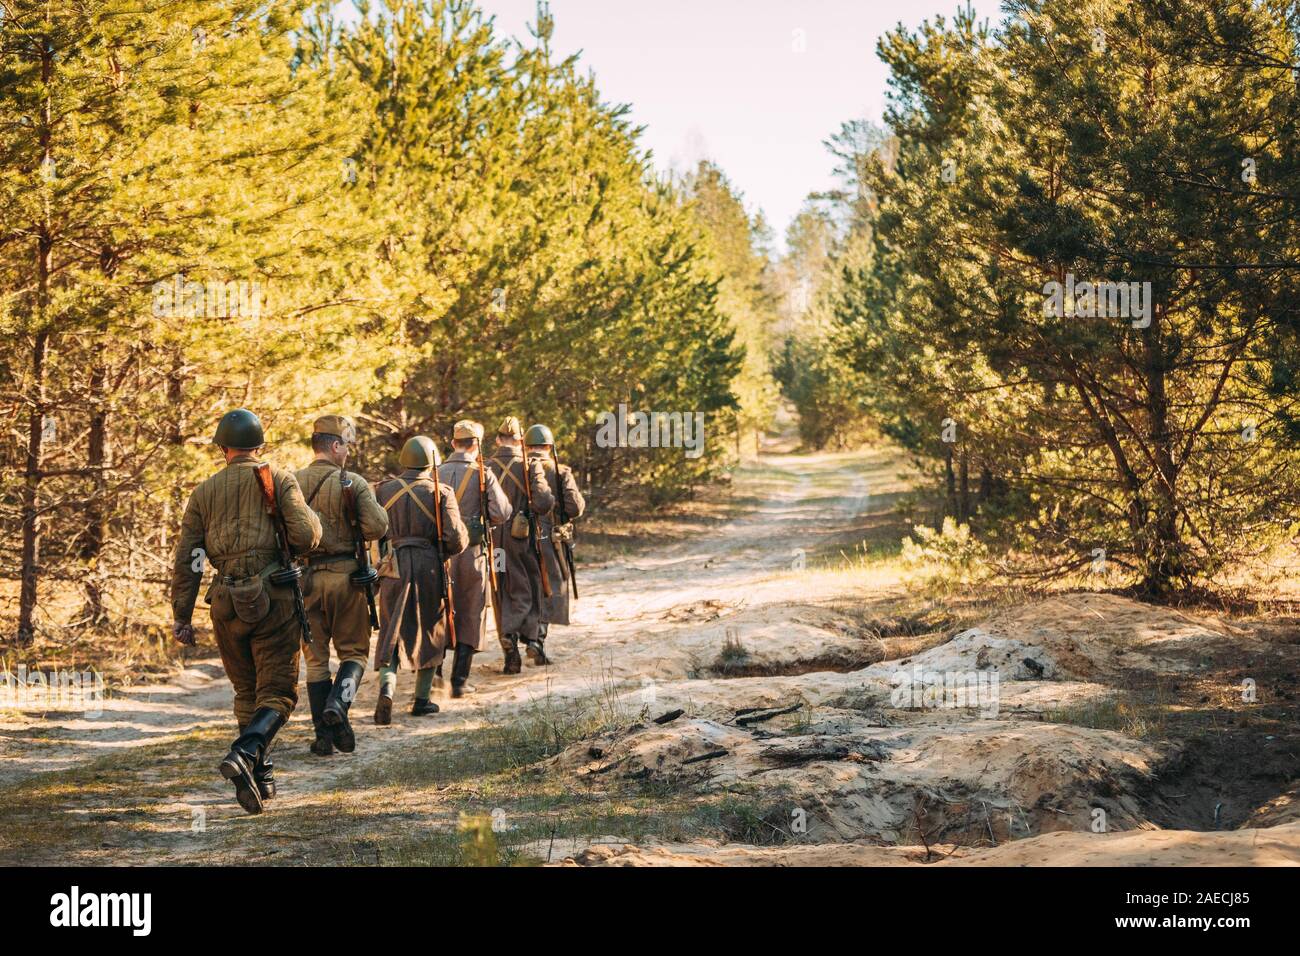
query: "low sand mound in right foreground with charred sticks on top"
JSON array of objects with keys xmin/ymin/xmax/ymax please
[{"xmin": 553, "ymin": 708, "xmax": 1165, "ymax": 844}]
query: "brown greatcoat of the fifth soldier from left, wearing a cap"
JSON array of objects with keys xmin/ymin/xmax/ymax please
[{"xmin": 488, "ymin": 445, "xmax": 555, "ymax": 640}]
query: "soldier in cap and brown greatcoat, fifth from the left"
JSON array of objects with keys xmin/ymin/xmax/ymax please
[{"xmin": 488, "ymin": 416, "xmax": 555, "ymax": 674}]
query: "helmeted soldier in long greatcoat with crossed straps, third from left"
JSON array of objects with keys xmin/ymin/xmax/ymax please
[{"xmin": 374, "ymin": 434, "xmax": 469, "ymax": 724}]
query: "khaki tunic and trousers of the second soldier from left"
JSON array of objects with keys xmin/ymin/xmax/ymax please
[{"xmin": 296, "ymin": 460, "xmax": 389, "ymax": 682}]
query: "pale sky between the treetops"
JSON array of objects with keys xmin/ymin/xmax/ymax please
[{"xmin": 340, "ymin": 0, "xmax": 998, "ymax": 248}]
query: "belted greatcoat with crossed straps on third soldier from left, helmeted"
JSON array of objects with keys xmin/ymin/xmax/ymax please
[{"xmin": 374, "ymin": 468, "xmax": 469, "ymax": 669}]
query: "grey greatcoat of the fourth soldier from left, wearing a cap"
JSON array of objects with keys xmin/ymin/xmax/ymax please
[{"xmin": 434, "ymin": 451, "xmax": 512, "ymax": 653}]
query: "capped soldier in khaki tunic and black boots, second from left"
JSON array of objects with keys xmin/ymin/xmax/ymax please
[{"xmin": 296, "ymin": 415, "xmax": 389, "ymax": 757}]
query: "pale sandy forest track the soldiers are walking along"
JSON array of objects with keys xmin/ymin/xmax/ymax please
[{"xmin": 0, "ymin": 449, "xmax": 909, "ymax": 862}]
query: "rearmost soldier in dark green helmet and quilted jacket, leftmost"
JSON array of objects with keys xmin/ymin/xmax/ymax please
[{"xmin": 172, "ymin": 408, "xmax": 321, "ymax": 813}]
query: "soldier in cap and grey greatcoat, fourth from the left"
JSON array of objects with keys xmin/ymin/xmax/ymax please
[{"xmin": 436, "ymin": 420, "xmax": 511, "ymax": 697}]
